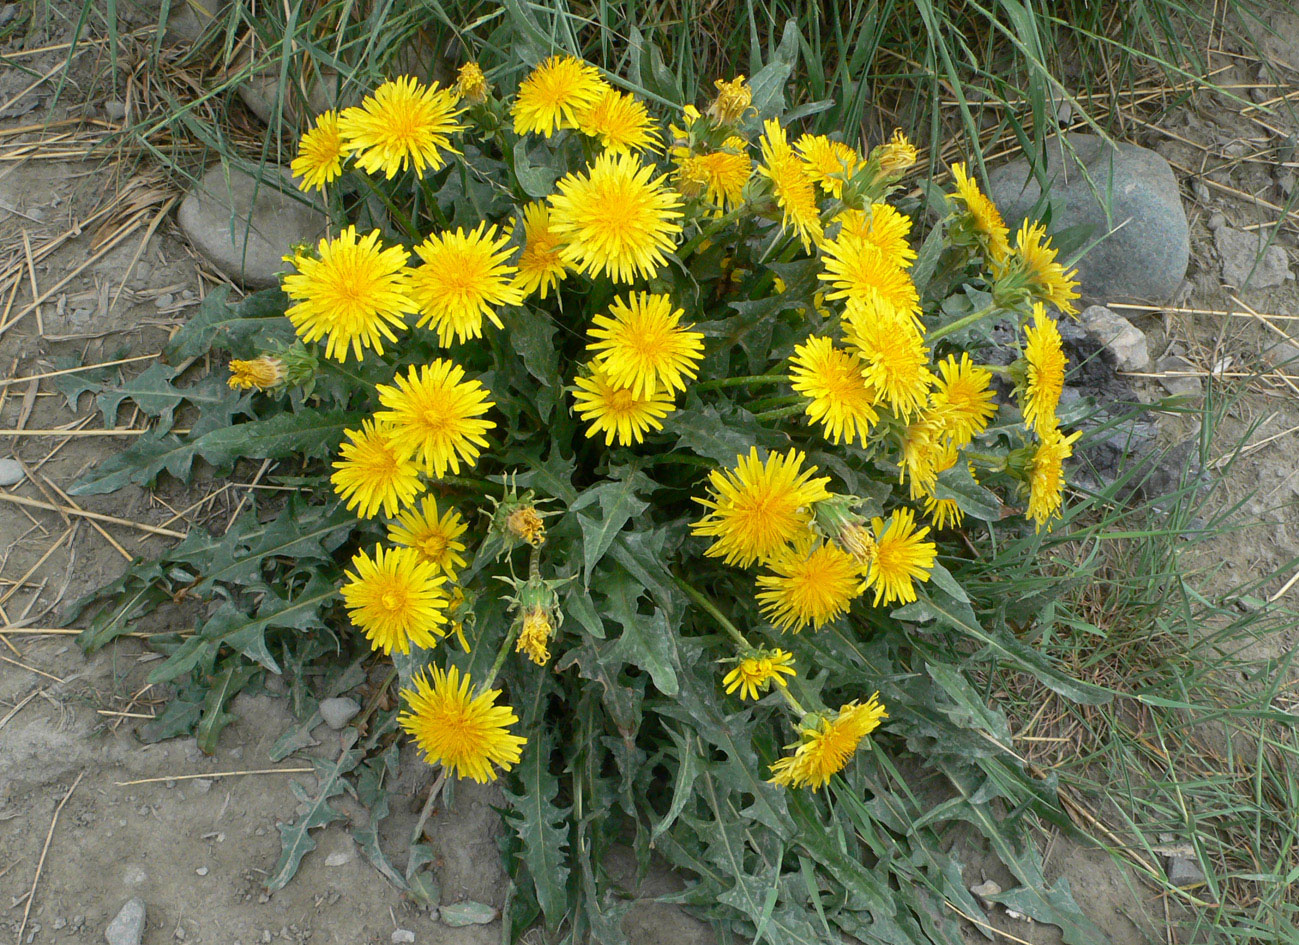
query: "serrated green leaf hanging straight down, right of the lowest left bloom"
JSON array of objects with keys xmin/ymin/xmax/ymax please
[{"xmin": 505, "ymin": 725, "xmax": 572, "ymax": 928}]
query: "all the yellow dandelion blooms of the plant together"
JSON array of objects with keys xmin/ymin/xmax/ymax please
[{"xmin": 271, "ymin": 56, "xmax": 1078, "ymax": 790}]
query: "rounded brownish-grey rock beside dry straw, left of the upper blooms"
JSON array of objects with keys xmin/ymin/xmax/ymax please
[{"xmin": 177, "ymin": 164, "xmax": 325, "ymax": 287}]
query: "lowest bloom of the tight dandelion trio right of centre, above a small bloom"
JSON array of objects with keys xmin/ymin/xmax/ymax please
[{"xmin": 757, "ymin": 537, "xmax": 861, "ymax": 633}]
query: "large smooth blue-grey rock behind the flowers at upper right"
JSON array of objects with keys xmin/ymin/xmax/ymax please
[{"xmin": 989, "ymin": 134, "xmax": 1191, "ymax": 302}]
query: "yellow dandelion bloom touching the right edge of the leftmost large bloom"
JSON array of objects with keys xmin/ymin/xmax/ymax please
[{"xmin": 410, "ymin": 224, "xmax": 523, "ymax": 346}]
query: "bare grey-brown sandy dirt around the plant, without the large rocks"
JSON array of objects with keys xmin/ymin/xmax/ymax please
[{"xmin": 0, "ymin": 7, "xmax": 1299, "ymax": 945}]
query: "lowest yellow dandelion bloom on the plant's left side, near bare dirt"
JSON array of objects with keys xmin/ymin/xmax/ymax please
[{"xmin": 397, "ymin": 667, "xmax": 527, "ymax": 784}]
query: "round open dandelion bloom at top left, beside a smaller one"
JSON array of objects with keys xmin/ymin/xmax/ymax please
[{"xmin": 338, "ymin": 75, "xmax": 465, "ymax": 181}]
